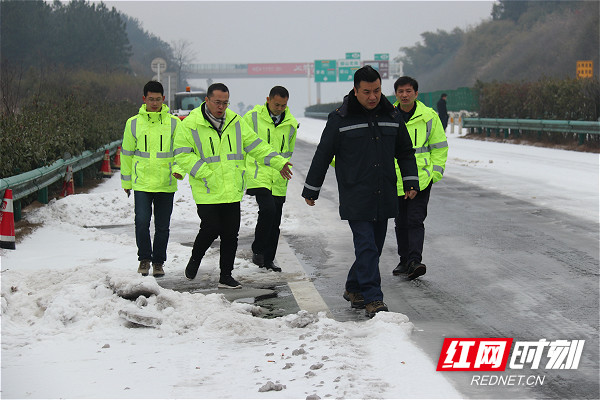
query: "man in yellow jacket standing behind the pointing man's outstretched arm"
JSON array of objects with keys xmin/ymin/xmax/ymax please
[{"xmin": 244, "ymin": 86, "xmax": 298, "ymax": 272}]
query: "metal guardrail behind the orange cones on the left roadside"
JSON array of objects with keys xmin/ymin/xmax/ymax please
[{"xmin": 0, "ymin": 140, "xmax": 122, "ymax": 221}]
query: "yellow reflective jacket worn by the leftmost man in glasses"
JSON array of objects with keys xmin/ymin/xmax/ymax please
[{"xmin": 121, "ymin": 104, "xmax": 184, "ymax": 193}]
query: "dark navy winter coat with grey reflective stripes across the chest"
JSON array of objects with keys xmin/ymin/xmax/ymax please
[{"xmin": 302, "ymin": 91, "xmax": 419, "ymax": 221}]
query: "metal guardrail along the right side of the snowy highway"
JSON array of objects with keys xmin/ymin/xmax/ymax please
[{"xmin": 463, "ymin": 118, "xmax": 600, "ymax": 145}]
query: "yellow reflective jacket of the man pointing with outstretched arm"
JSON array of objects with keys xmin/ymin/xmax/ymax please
[{"xmin": 175, "ymin": 103, "xmax": 286, "ymax": 204}]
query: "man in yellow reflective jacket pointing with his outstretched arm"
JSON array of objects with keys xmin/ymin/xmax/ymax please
[{"xmin": 175, "ymin": 83, "xmax": 292, "ymax": 289}]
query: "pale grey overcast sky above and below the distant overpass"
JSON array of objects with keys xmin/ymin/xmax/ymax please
[{"xmin": 105, "ymin": 0, "xmax": 494, "ymax": 116}]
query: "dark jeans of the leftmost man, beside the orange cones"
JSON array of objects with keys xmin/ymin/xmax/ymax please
[{"xmin": 133, "ymin": 190, "xmax": 175, "ymax": 264}]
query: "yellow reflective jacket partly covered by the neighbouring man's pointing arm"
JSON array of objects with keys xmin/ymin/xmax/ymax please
[{"xmin": 244, "ymin": 104, "xmax": 298, "ymax": 196}]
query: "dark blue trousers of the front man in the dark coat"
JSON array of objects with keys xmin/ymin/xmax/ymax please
[{"xmin": 346, "ymin": 220, "xmax": 387, "ymax": 303}]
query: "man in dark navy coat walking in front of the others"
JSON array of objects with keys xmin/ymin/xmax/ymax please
[{"xmin": 302, "ymin": 66, "xmax": 419, "ymax": 317}]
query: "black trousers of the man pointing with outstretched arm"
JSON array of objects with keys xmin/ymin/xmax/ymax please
[{"xmin": 192, "ymin": 202, "xmax": 240, "ymax": 276}]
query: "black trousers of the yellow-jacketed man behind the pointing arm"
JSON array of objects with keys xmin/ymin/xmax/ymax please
[{"xmin": 252, "ymin": 192, "xmax": 285, "ymax": 264}]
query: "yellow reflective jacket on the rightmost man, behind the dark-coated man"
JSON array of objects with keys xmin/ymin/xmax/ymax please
[{"xmin": 394, "ymin": 100, "xmax": 448, "ymax": 196}]
